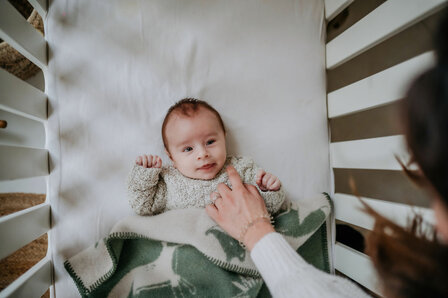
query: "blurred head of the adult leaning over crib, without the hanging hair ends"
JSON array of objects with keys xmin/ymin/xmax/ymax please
[{"xmin": 401, "ymin": 9, "xmax": 448, "ymax": 240}]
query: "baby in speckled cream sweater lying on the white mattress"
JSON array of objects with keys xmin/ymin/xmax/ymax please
[{"xmin": 128, "ymin": 98, "xmax": 285, "ymax": 215}]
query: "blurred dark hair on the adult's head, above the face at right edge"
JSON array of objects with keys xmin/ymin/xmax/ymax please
[{"xmin": 401, "ymin": 66, "xmax": 448, "ymax": 206}]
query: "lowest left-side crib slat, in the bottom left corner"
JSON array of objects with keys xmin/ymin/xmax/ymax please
[{"xmin": 0, "ymin": 257, "xmax": 52, "ymax": 297}]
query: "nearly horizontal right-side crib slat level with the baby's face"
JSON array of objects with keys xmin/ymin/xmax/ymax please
[{"xmin": 330, "ymin": 135, "xmax": 409, "ymax": 170}]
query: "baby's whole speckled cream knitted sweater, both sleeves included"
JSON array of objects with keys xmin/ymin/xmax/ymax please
[{"xmin": 127, "ymin": 156, "xmax": 285, "ymax": 215}]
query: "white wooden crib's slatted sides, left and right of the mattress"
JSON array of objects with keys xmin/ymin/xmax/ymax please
[{"xmin": 0, "ymin": 0, "xmax": 447, "ymax": 297}]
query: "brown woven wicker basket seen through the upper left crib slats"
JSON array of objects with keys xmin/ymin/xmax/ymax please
[{"xmin": 0, "ymin": 10, "xmax": 44, "ymax": 80}]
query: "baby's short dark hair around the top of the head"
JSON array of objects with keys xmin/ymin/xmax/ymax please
[{"xmin": 162, "ymin": 98, "xmax": 226, "ymax": 152}]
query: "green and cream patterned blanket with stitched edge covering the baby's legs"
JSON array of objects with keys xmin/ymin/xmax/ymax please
[{"xmin": 64, "ymin": 194, "xmax": 331, "ymax": 297}]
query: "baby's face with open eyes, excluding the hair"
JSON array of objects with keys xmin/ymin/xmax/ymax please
[{"xmin": 165, "ymin": 107, "xmax": 227, "ymax": 180}]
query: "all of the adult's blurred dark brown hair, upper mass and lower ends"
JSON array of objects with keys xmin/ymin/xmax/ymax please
[{"xmin": 363, "ymin": 10, "xmax": 448, "ymax": 297}]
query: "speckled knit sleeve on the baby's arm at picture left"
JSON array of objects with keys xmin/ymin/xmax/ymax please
[{"xmin": 127, "ymin": 164, "xmax": 166, "ymax": 215}]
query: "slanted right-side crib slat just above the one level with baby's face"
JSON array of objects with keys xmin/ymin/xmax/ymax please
[{"xmin": 328, "ymin": 52, "xmax": 435, "ymax": 118}]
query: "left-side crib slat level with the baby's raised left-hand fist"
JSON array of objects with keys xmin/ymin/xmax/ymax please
[{"xmin": 0, "ymin": 146, "xmax": 49, "ymax": 180}]
